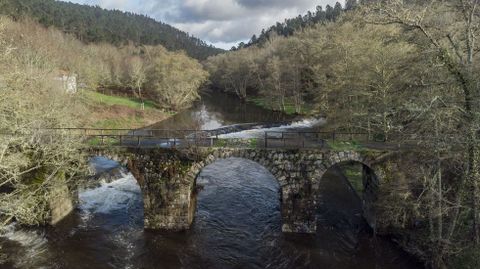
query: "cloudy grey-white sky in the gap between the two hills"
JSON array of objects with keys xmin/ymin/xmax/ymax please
[{"xmin": 70, "ymin": 0, "xmax": 343, "ymax": 49}]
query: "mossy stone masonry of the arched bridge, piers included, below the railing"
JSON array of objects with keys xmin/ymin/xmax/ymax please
[{"xmin": 88, "ymin": 148, "xmax": 379, "ymax": 233}]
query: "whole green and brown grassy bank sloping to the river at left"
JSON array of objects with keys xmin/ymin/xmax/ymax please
[{"xmin": 82, "ymin": 91, "xmax": 172, "ymax": 129}]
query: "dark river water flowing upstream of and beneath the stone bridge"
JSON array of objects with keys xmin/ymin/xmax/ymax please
[{"xmin": 0, "ymin": 91, "xmax": 422, "ymax": 269}]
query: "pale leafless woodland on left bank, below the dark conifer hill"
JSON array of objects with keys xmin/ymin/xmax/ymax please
[{"xmin": 0, "ymin": 14, "xmax": 208, "ymax": 234}]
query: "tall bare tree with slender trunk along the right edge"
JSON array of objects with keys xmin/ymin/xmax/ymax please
[{"xmin": 369, "ymin": 0, "xmax": 480, "ymax": 245}]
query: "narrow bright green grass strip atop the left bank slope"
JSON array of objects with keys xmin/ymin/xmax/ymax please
[{"xmin": 84, "ymin": 91, "xmax": 157, "ymax": 110}]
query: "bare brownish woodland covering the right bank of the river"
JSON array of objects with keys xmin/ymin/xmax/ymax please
[{"xmin": 205, "ymin": 0, "xmax": 480, "ymax": 268}]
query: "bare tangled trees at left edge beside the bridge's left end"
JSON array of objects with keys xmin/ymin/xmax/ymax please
[{"xmin": 0, "ymin": 17, "xmax": 85, "ymax": 225}]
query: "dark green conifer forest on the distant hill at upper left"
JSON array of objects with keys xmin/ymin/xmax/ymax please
[{"xmin": 0, "ymin": 0, "xmax": 222, "ymax": 59}]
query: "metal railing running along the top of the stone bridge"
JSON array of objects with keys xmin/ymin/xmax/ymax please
[{"xmin": 30, "ymin": 128, "xmax": 406, "ymax": 149}]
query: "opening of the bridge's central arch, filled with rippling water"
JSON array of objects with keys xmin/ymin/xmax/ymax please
[{"xmin": 191, "ymin": 155, "xmax": 283, "ymax": 228}]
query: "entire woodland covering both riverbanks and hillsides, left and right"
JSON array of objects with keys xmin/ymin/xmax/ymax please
[{"xmin": 0, "ymin": 0, "xmax": 480, "ymax": 268}]
